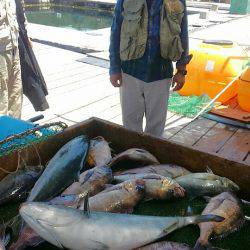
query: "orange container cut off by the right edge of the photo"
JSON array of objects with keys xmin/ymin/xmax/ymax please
[{"xmin": 238, "ymin": 67, "xmax": 250, "ymax": 112}]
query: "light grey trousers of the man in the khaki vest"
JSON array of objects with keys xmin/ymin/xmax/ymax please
[{"xmin": 120, "ymin": 73, "xmax": 172, "ymax": 137}]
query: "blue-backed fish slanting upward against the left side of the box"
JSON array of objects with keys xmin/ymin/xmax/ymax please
[{"xmin": 28, "ymin": 136, "xmax": 89, "ymax": 201}]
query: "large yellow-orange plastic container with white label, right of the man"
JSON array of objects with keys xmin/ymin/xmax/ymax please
[{"xmin": 179, "ymin": 41, "xmax": 246, "ymax": 103}]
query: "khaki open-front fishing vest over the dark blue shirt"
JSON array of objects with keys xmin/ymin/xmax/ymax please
[{"xmin": 120, "ymin": 0, "xmax": 184, "ymax": 62}]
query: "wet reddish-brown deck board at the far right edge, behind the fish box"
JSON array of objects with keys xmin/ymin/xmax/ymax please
[{"xmin": 218, "ymin": 129, "xmax": 250, "ymax": 161}]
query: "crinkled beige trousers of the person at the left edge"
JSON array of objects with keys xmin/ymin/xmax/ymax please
[{"xmin": 0, "ymin": 49, "xmax": 23, "ymax": 118}]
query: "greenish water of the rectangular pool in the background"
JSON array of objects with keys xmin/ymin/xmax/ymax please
[{"xmin": 26, "ymin": 7, "xmax": 113, "ymax": 31}]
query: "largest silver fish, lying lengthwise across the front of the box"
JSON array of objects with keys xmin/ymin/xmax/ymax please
[{"xmin": 19, "ymin": 202, "xmax": 224, "ymax": 250}]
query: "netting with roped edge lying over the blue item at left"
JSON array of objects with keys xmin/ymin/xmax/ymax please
[{"xmin": 0, "ymin": 122, "xmax": 67, "ymax": 157}]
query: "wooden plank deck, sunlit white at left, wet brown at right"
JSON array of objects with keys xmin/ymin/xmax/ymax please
[{"xmin": 22, "ymin": 43, "xmax": 250, "ymax": 166}]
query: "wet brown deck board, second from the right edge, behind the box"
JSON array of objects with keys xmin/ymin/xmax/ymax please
[{"xmin": 194, "ymin": 123, "xmax": 237, "ymax": 153}]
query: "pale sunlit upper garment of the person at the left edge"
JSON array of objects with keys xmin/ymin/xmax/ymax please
[{"xmin": 0, "ymin": 0, "xmax": 18, "ymax": 52}]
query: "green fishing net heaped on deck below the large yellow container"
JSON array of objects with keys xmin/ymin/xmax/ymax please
[{"xmin": 168, "ymin": 92, "xmax": 213, "ymax": 118}]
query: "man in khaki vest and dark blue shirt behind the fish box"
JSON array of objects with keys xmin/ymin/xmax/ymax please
[{"xmin": 109, "ymin": 0, "xmax": 191, "ymax": 136}]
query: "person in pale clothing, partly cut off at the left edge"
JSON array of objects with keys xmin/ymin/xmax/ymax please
[{"xmin": 0, "ymin": 0, "xmax": 23, "ymax": 118}]
